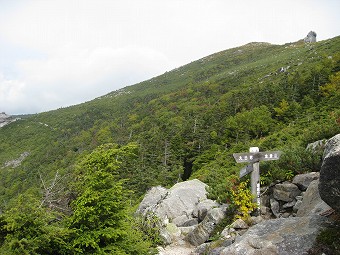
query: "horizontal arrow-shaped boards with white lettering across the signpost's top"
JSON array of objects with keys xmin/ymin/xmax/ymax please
[{"xmin": 233, "ymin": 151, "xmax": 282, "ymax": 163}]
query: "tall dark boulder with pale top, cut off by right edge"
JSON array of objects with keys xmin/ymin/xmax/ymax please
[{"xmin": 319, "ymin": 134, "xmax": 340, "ymax": 213}]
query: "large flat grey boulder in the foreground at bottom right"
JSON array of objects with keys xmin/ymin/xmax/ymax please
[{"xmin": 215, "ymin": 215, "xmax": 330, "ymax": 255}]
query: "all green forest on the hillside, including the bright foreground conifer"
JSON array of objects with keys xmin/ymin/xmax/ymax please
[{"xmin": 0, "ymin": 36, "xmax": 340, "ymax": 254}]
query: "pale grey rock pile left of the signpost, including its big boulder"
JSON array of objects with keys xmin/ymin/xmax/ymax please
[{"xmin": 137, "ymin": 180, "xmax": 225, "ymax": 245}]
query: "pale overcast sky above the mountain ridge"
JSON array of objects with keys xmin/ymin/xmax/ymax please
[{"xmin": 0, "ymin": 0, "xmax": 340, "ymax": 115}]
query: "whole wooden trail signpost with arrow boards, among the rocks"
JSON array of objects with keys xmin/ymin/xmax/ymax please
[{"xmin": 233, "ymin": 147, "xmax": 282, "ymax": 208}]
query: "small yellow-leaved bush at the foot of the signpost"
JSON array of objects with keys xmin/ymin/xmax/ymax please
[{"xmin": 231, "ymin": 181, "xmax": 257, "ymax": 221}]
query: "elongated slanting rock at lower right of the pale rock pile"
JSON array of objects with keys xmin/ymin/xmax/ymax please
[{"xmin": 186, "ymin": 208, "xmax": 225, "ymax": 246}]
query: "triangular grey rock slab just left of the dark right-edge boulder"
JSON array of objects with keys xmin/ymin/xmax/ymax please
[{"xmin": 296, "ymin": 180, "xmax": 331, "ymax": 217}]
